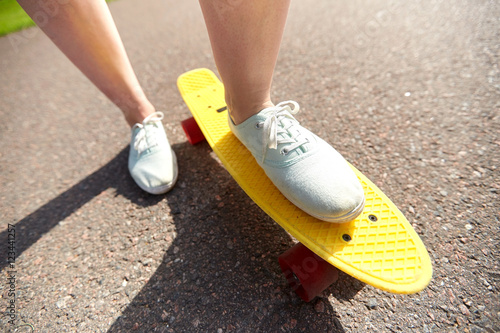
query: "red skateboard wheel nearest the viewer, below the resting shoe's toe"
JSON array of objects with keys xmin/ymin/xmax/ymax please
[{"xmin": 278, "ymin": 243, "xmax": 338, "ymax": 302}]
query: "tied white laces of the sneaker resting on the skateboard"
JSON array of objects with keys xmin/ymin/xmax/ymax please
[{"xmin": 257, "ymin": 101, "xmax": 309, "ymax": 161}]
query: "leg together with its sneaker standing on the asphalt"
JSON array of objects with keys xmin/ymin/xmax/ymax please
[{"xmin": 18, "ymin": 0, "xmax": 178, "ymax": 194}]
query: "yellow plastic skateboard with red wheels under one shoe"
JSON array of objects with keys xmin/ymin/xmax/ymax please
[{"xmin": 177, "ymin": 69, "xmax": 432, "ymax": 301}]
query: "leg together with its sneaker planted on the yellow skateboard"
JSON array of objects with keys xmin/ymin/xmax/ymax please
[{"xmin": 199, "ymin": 0, "xmax": 364, "ymax": 223}]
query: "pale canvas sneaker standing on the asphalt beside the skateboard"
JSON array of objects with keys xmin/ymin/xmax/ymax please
[{"xmin": 128, "ymin": 112, "xmax": 178, "ymax": 194}]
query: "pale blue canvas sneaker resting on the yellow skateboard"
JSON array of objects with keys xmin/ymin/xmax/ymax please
[{"xmin": 229, "ymin": 101, "xmax": 365, "ymax": 223}]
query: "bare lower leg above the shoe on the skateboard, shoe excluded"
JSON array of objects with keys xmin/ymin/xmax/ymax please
[{"xmin": 200, "ymin": 0, "xmax": 290, "ymax": 124}]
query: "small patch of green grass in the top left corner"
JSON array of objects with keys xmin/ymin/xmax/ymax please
[{"xmin": 0, "ymin": 0, "xmax": 35, "ymax": 36}]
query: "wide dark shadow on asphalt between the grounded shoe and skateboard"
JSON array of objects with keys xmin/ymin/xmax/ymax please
[{"xmin": 108, "ymin": 143, "xmax": 359, "ymax": 333}]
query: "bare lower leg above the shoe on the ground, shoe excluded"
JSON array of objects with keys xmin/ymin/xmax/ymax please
[{"xmin": 18, "ymin": 0, "xmax": 155, "ymax": 126}]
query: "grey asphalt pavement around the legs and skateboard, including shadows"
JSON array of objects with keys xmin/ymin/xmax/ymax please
[{"xmin": 0, "ymin": 0, "xmax": 500, "ymax": 332}]
